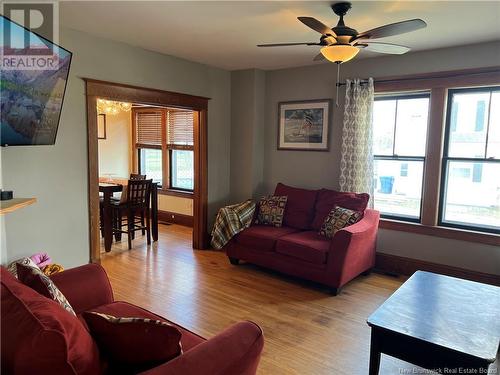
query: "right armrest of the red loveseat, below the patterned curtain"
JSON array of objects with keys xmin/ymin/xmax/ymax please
[{"xmin": 328, "ymin": 209, "xmax": 380, "ymax": 287}]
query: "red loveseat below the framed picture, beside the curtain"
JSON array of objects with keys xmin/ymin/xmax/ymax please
[{"xmin": 224, "ymin": 183, "xmax": 380, "ymax": 295}]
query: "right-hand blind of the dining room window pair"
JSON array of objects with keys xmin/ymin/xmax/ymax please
[{"xmin": 167, "ymin": 110, "xmax": 194, "ymax": 150}]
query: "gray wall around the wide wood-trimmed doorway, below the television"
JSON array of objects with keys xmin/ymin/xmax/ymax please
[{"xmin": 1, "ymin": 29, "xmax": 231, "ymax": 267}]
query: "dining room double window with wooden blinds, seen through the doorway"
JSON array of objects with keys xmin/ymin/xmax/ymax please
[{"xmin": 133, "ymin": 108, "xmax": 194, "ymax": 191}]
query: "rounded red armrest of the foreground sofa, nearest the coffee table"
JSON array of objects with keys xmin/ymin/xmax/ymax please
[{"xmin": 141, "ymin": 322, "xmax": 264, "ymax": 375}]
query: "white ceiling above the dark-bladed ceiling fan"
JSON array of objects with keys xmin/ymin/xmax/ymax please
[{"xmin": 60, "ymin": 1, "xmax": 500, "ymax": 70}]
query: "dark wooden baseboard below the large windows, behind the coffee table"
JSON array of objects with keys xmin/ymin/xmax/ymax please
[{"xmin": 375, "ymin": 253, "xmax": 500, "ymax": 286}]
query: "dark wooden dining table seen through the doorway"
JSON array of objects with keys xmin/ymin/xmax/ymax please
[{"xmin": 99, "ymin": 179, "xmax": 158, "ymax": 252}]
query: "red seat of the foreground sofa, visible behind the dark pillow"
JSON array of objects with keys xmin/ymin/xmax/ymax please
[{"xmin": 92, "ymin": 301, "xmax": 205, "ymax": 352}]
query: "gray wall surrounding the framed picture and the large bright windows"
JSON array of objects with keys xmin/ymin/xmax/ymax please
[{"xmin": 244, "ymin": 42, "xmax": 500, "ymax": 274}]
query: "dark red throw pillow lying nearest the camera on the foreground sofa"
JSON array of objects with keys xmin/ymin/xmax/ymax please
[{"xmin": 83, "ymin": 311, "xmax": 182, "ymax": 373}]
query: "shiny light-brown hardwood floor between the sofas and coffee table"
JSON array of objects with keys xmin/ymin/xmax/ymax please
[{"xmin": 98, "ymin": 225, "xmax": 496, "ymax": 375}]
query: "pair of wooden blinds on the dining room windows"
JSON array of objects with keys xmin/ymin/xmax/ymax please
[{"xmin": 135, "ymin": 109, "xmax": 194, "ymax": 150}]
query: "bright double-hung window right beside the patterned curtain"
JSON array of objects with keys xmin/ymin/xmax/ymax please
[{"xmin": 373, "ymin": 94, "xmax": 429, "ymax": 221}]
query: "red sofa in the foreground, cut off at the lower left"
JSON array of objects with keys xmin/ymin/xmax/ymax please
[{"xmin": 0, "ymin": 264, "xmax": 264, "ymax": 375}]
